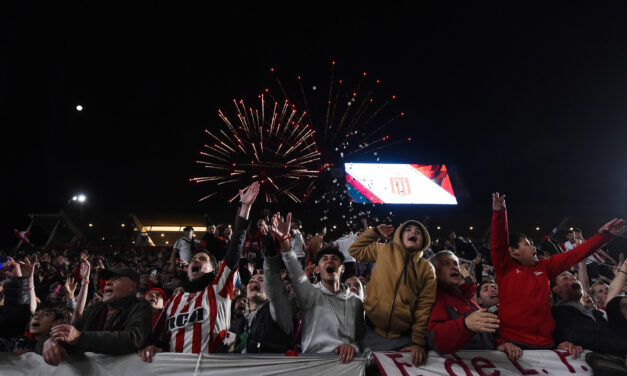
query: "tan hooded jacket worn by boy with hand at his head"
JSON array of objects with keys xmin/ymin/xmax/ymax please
[{"xmin": 349, "ymin": 221, "xmax": 436, "ymax": 347}]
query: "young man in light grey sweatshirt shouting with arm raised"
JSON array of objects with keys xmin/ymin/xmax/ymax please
[{"xmin": 268, "ymin": 213, "xmax": 364, "ymax": 363}]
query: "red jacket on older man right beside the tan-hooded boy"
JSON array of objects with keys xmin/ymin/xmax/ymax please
[{"xmin": 427, "ymin": 283, "xmax": 487, "ymax": 354}]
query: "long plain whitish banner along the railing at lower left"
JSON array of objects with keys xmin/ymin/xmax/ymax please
[{"xmin": 0, "ymin": 353, "xmax": 366, "ymax": 376}]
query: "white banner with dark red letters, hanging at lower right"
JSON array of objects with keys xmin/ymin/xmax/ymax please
[{"xmin": 373, "ymin": 350, "xmax": 592, "ymax": 376}]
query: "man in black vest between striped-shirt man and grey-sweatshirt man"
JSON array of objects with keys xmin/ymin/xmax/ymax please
[{"xmin": 231, "ymin": 270, "xmax": 292, "ymax": 354}]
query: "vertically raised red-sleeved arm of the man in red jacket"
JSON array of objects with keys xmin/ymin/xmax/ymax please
[{"xmin": 490, "ymin": 192, "xmax": 515, "ymax": 278}]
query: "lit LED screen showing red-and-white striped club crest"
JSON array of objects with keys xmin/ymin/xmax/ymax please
[{"xmin": 344, "ymin": 163, "xmax": 457, "ymax": 205}]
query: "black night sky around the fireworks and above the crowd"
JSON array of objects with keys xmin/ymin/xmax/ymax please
[{"xmin": 0, "ymin": 1, "xmax": 627, "ymax": 246}]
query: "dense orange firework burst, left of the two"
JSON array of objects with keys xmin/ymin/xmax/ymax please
[{"xmin": 190, "ymin": 94, "xmax": 321, "ymax": 202}]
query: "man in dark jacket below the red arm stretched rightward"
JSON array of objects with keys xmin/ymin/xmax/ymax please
[{"xmin": 551, "ymin": 272, "xmax": 627, "ymax": 355}]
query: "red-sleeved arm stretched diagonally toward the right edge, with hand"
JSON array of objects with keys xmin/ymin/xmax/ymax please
[{"xmin": 546, "ymin": 219, "xmax": 625, "ymax": 278}]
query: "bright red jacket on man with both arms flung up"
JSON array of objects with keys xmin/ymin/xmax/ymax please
[{"xmin": 490, "ymin": 210, "xmax": 612, "ymax": 347}]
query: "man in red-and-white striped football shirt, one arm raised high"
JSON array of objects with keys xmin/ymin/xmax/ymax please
[{"xmin": 138, "ymin": 182, "xmax": 259, "ymax": 362}]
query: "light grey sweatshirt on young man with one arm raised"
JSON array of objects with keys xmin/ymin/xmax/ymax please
[{"xmin": 282, "ymin": 251, "xmax": 364, "ymax": 353}]
